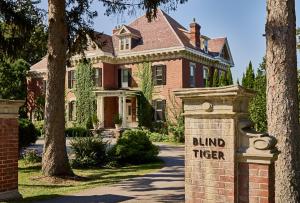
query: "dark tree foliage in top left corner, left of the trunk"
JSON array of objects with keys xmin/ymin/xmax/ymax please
[{"xmin": 0, "ymin": 0, "xmax": 47, "ymax": 64}]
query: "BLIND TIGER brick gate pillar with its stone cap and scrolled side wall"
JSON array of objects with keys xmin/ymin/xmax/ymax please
[{"xmin": 174, "ymin": 86, "xmax": 276, "ymax": 203}]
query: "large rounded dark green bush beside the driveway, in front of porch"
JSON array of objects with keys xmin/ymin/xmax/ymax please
[{"xmin": 109, "ymin": 130, "xmax": 158, "ymax": 165}]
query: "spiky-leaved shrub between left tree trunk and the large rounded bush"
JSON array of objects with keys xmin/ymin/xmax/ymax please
[{"xmin": 70, "ymin": 137, "xmax": 106, "ymax": 168}]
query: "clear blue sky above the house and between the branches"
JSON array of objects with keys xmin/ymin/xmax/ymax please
[{"xmin": 40, "ymin": 0, "xmax": 300, "ymax": 81}]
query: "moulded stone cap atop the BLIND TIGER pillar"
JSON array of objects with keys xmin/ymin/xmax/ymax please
[{"xmin": 174, "ymin": 85, "xmax": 255, "ymax": 116}]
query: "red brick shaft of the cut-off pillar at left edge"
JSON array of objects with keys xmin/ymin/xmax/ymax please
[{"xmin": 0, "ymin": 118, "xmax": 18, "ymax": 192}]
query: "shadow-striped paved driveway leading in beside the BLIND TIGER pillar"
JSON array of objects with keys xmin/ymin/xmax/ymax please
[{"xmin": 36, "ymin": 145, "xmax": 184, "ymax": 203}]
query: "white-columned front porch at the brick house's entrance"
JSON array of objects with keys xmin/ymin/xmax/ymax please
[{"xmin": 95, "ymin": 90, "xmax": 139, "ymax": 128}]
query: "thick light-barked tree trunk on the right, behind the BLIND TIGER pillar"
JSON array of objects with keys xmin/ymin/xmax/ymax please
[{"xmin": 266, "ymin": 0, "xmax": 300, "ymax": 203}]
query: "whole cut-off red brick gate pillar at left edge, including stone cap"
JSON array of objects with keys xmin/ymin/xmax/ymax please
[{"xmin": 0, "ymin": 99, "xmax": 24, "ymax": 202}]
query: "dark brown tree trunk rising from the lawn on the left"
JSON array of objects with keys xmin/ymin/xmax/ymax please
[{"xmin": 42, "ymin": 0, "xmax": 73, "ymax": 176}]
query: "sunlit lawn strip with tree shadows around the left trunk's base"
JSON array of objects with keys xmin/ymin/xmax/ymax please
[{"xmin": 18, "ymin": 160, "xmax": 163, "ymax": 202}]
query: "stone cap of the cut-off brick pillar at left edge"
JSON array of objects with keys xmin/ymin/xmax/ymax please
[{"xmin": 0, "ymin": 99, "xmax": 25, "ymax": 118}]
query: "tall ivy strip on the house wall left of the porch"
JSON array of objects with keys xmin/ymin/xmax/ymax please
[{"xmin": 74, "ymin": 61, "xmax": 95, "ymax": 128}]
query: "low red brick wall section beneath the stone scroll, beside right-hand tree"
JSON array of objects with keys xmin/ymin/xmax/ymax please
[{"xmin": 238, "ymin": 163, "xmax": 275, "ymax": 203}]
